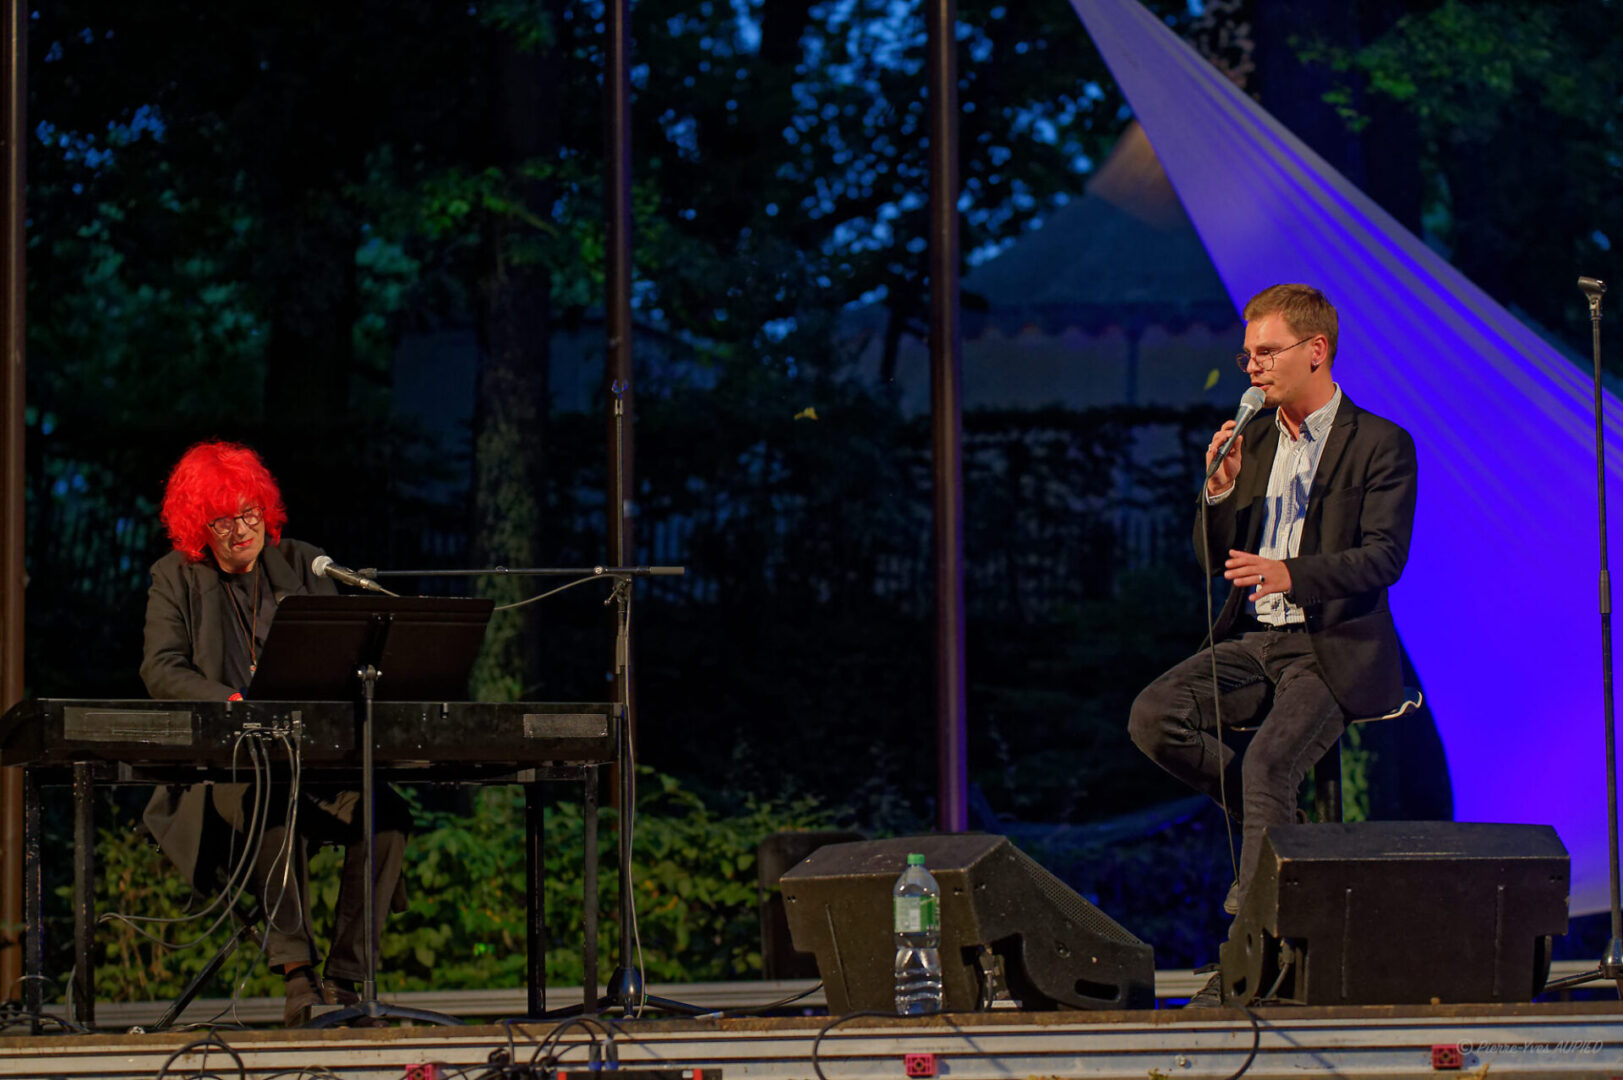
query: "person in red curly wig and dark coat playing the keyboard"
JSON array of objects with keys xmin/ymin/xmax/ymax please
[{"xmin": 141, "ymin": 442, "xmax": 411, "ymax": 1026}]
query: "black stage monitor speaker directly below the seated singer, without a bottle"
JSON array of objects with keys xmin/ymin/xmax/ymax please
[{"xmin": 1220, "ymin": 822, "xmax": 1571, "ymax": 1005}]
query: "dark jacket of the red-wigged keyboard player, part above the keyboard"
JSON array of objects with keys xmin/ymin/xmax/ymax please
[{"xmin": 141, "ymin": 539, "xmax": 338, "ymax": 702}]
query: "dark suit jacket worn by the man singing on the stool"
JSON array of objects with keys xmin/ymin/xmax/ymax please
[{"xmin": 1195, "ymin": 393, "xmax": 1417, "ymax": 716}]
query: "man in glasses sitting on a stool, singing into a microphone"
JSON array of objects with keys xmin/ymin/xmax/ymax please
[{"xmin": 1128, "ymin": 284, "xmax": 1417, "ymax": 941}]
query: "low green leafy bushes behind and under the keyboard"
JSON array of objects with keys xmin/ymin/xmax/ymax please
[{"xmin": 73, "ymin": 770, "xmax": 831, "ymax": 1000}]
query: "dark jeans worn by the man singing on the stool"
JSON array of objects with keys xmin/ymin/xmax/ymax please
[{"xmin": 1128, "ymin": 630, "xmax": 1347, "ymax": 915}]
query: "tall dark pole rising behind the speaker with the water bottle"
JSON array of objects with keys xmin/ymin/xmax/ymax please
[{"xmin": 925, "ymin": 0, "xmax": 969, "ymax": 833}]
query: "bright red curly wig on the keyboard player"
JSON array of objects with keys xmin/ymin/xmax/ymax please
[{"xmin": 159, "ymin": 442, "xmax": 287, "ymax": 562}]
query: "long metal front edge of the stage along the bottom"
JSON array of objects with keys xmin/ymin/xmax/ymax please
[{"xmin": 0, "ymin": 1002, "xmax": 1623, "ymax": 1080}]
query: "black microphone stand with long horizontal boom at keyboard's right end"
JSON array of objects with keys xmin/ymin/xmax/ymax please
[{"xmin": 357, "ymin": 567, "xmax": 712, "ymax": 1018}]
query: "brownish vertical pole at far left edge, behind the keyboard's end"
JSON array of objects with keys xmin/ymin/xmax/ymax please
[{"xmin": 0, "ymin": 0, "xmax": 28, "ymax": 999}]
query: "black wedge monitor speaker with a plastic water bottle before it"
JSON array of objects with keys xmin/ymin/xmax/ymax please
[{"xmin": 779, "ymin": 835, "xmax": 1156, "ymax": 1015}]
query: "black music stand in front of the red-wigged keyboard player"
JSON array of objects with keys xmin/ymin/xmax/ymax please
[{"xmin": 248, "ymin": 596, "xmax": 495, "ymax": 1028}]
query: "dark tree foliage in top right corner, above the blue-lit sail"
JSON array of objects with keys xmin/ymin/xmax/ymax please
[{"xmin": 1305, "ymin": 0, "xmax": 1623, "ymax": 357}]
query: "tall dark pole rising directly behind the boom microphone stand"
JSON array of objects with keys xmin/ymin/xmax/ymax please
[{"xmin": 603, "ymin": 0, "xmax": 643, "ymax": 1010}]
